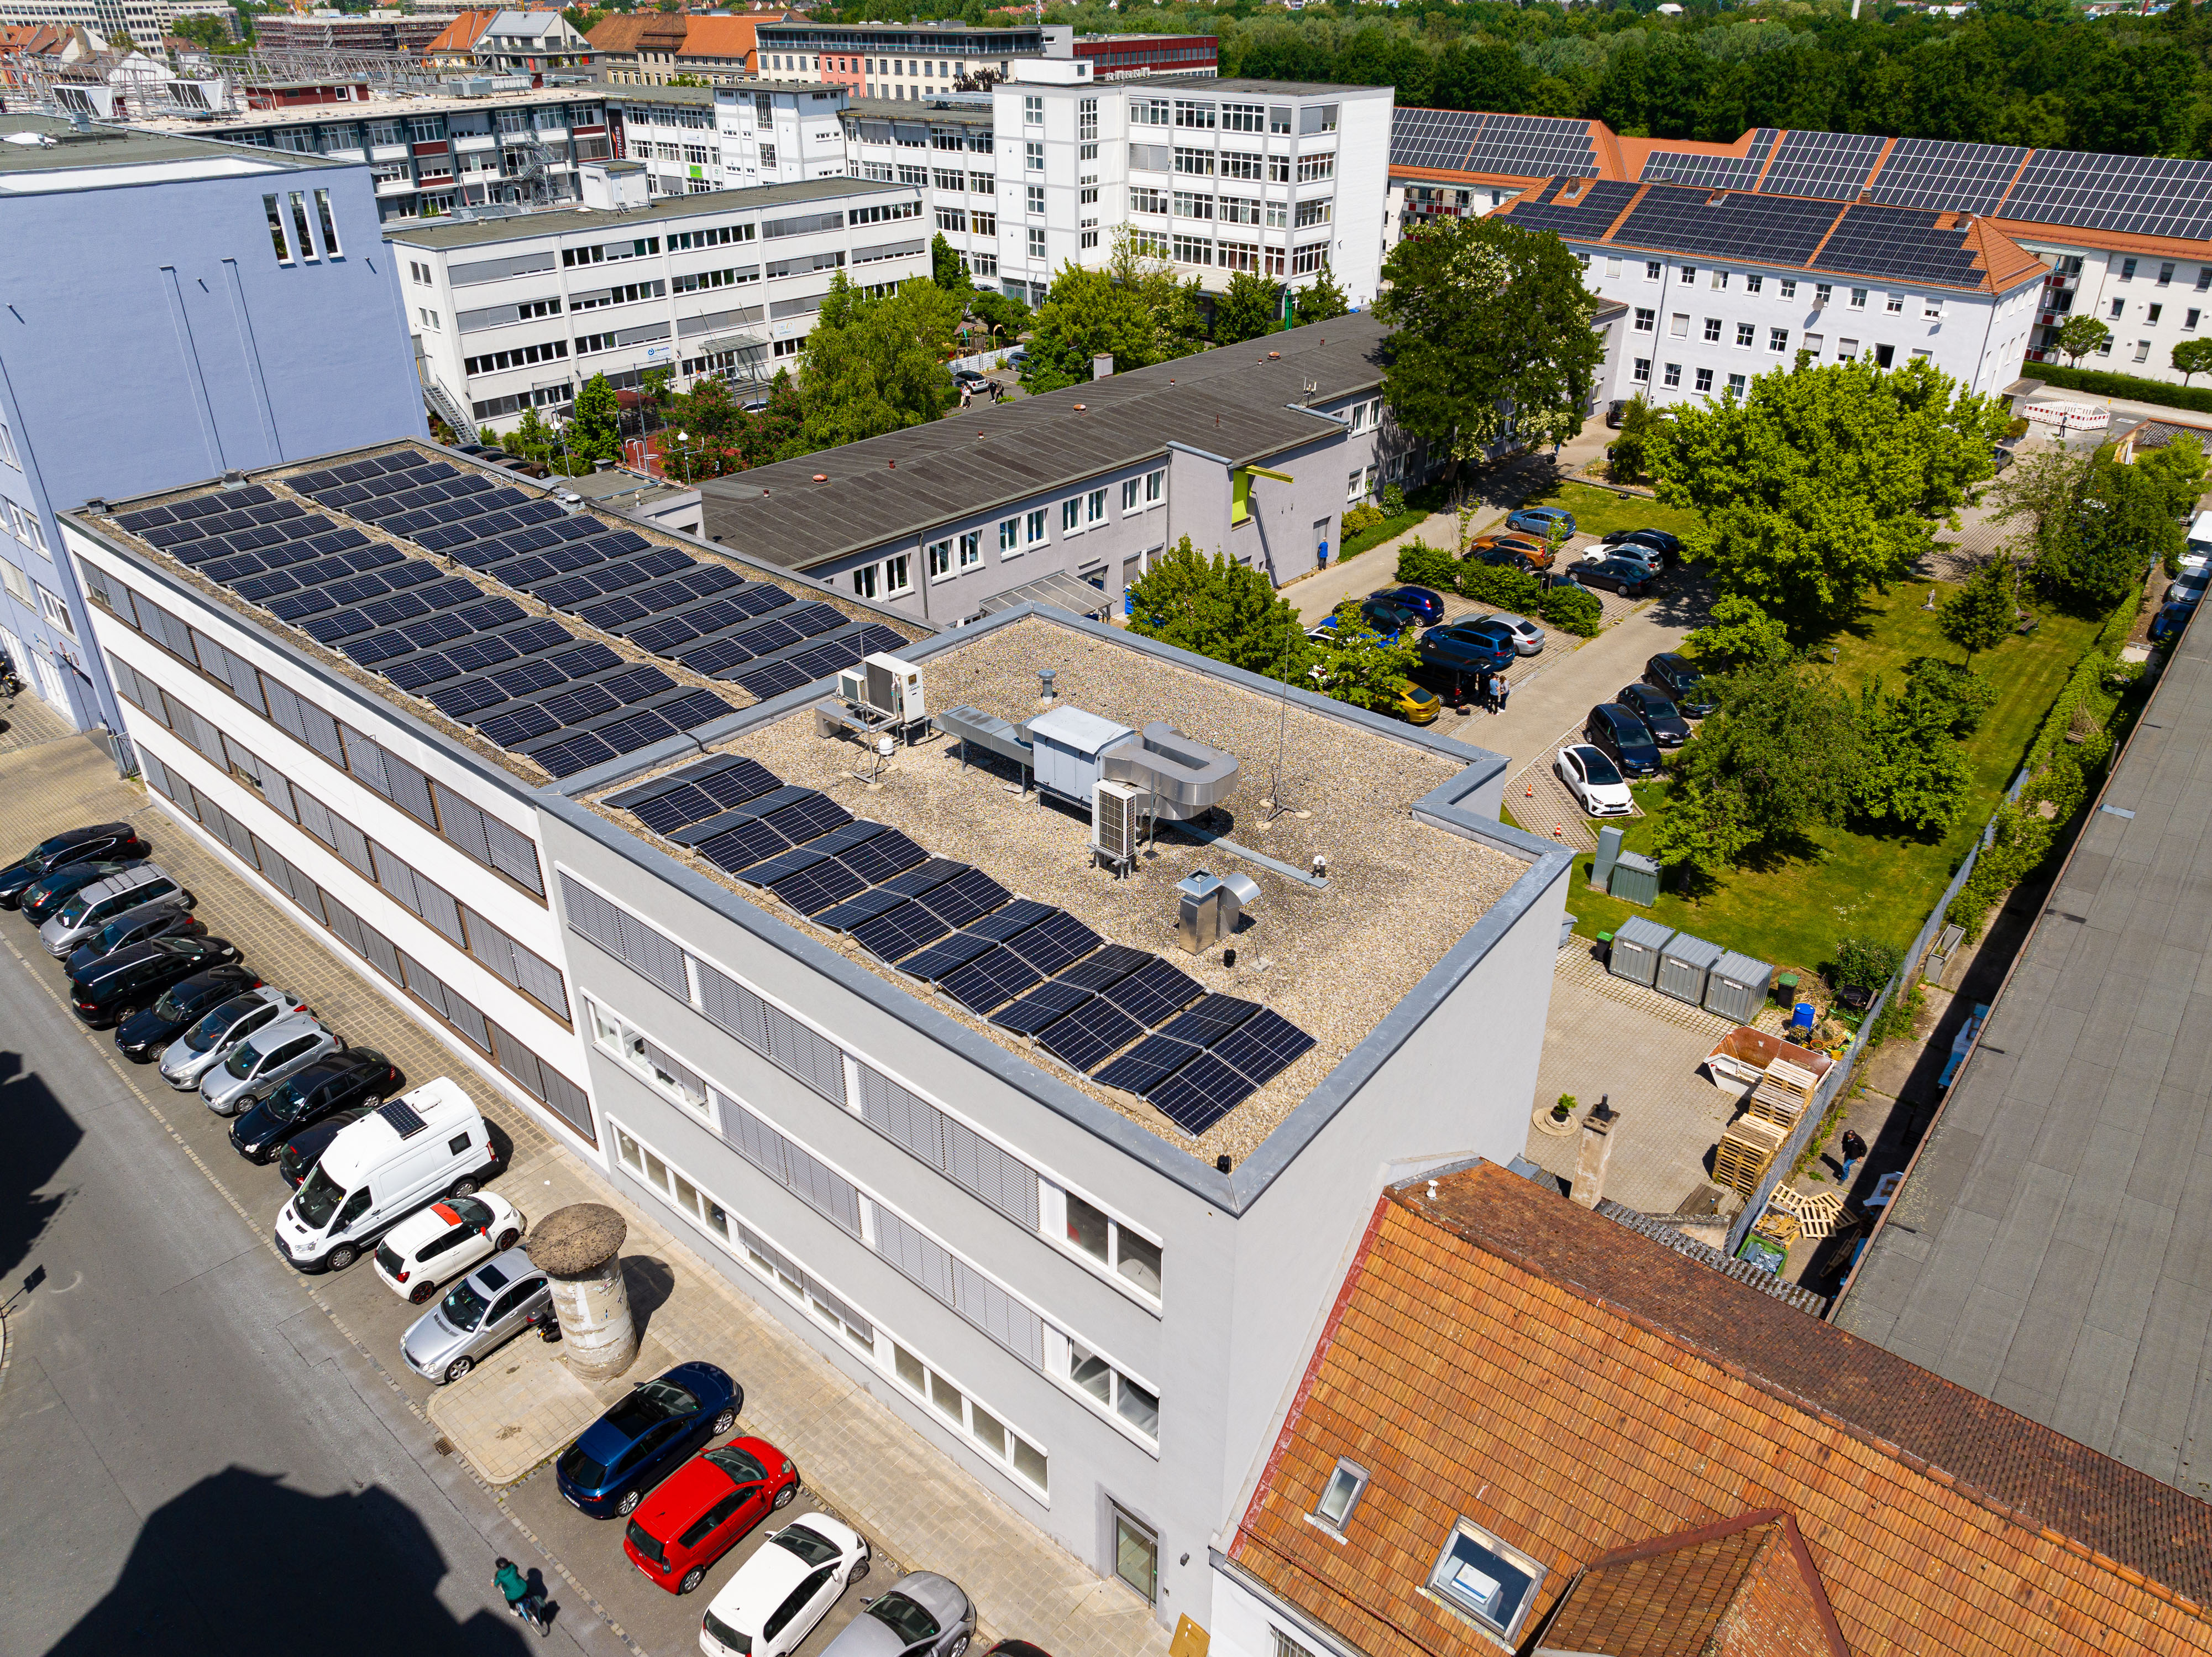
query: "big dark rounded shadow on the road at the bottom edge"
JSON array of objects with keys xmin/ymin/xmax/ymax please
[{"xmin": 49, "ymin": 1467, "xmax": 537, "ymax": 1657}]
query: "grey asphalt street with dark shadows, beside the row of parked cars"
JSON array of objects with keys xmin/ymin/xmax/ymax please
[{"xmin": 0, "ymin": 914, "xmax": 624, "ymax": 1657}]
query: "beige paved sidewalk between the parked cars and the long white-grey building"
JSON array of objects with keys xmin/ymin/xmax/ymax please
[{"xmin": 0, "ymin": 739, "xmax": 1168, "ymax": 1657}]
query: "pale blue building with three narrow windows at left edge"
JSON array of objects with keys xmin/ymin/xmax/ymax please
[{"xmin": 0, "ymin": 115, "xmax": 424, "ymax": 730}]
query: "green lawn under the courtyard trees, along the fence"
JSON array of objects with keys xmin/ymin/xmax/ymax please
[{"xmin": 1566, "ymin": 579, "xmax": 2097, "ymax": 971}]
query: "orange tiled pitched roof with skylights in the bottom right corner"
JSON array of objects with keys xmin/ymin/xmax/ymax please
[{"xmin": 1230, "ymin": 1164, "xmax": 2212, "ymax": 1657}]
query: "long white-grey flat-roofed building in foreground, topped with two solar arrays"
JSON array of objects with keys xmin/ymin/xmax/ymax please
[{"xmin": 69, "ymin": 427, "xmax": 1570, "ymax": 1626}]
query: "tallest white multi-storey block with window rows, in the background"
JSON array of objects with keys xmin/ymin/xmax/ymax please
[{"xmin": 991, "ymin": 60, "xmax": 1391, "ymax": 305}]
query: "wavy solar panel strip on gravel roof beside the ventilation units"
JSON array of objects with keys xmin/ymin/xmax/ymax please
[{"xmin": 606, "ymin": 754, "xmax": 1314, "ymax": 1137}]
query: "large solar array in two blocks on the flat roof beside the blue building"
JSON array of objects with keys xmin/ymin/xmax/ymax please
[{"xmin": 117, "ymin": 451, "xmax": 907, "ymax": 776}]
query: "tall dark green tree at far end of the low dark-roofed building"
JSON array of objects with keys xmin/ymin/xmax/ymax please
[{"xmin": 1376, "ymin": 219, "xmax": 1603, "ymax": 460}]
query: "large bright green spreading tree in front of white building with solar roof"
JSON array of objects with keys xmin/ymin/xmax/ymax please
[{"xmin": 1650, "ymin": 358, "xmax": 2009, "ymax": 639}]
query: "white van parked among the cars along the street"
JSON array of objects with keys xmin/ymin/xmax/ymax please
[{"xmin": 276, "ymin": 1075, "xmax": 500, "ymax": 1272}]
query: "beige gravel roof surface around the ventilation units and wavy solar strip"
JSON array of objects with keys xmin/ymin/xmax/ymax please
[{"xmin": 602, "ymin": 617, "xmax": 1526, "ymax": 1164}]
